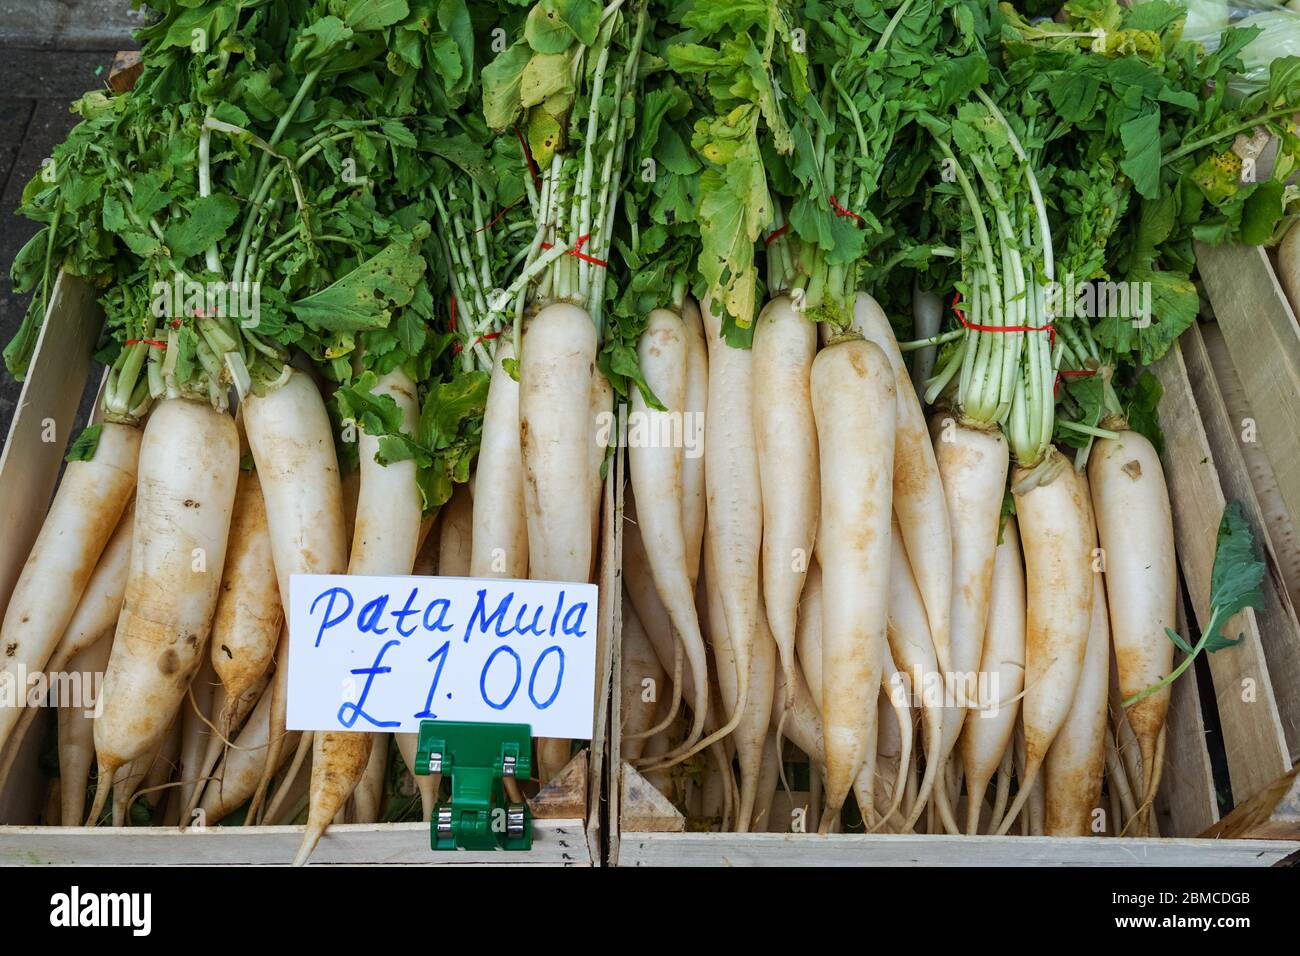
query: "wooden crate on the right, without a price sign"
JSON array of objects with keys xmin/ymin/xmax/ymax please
[{"xmin": 608, "ymin": 247, "xmax": 1300, "ymax": 866}]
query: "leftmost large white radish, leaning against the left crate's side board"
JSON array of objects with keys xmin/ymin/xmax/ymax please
[{"xmin": 0, "ymin": 421, "xmax": 142, "ymax": 752}]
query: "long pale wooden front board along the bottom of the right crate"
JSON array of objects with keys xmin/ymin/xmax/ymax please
[{"xmin": 619, "ymin": 834, "xmax": 1300, "ymax": 866}]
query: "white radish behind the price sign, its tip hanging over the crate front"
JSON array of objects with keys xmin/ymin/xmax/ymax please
[{"xmin": 294, "ymin": 368, "xmax": 423, "ymax": 866}]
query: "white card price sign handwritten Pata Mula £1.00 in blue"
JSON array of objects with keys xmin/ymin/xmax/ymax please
[{"xmin": 287, "ymin": 575, "xmax": 597, "ymax": 740}]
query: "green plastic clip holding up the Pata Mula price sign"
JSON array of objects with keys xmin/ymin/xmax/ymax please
[{"xmin": 415, "ymin": 721, "xmax": 533, "ymax": 851}]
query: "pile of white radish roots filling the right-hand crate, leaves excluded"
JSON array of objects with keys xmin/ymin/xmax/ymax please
[{"xmin": 620, "ymin": 293, "xmax": 1177, "ymax": 836}]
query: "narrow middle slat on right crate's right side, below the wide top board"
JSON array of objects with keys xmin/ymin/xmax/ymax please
[{"xmin": 1179, "ymin": 325, "xmax": 1300, "ymax": 764}]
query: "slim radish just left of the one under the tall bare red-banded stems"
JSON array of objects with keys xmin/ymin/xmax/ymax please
[{"xmin": 962, "ymin": 518, "xmax": 1024, "ymax": 834}]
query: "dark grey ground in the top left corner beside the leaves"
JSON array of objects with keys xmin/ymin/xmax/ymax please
[{"xmin": 0, "ymin": 0, "xmax": 143, "ymax": 442}]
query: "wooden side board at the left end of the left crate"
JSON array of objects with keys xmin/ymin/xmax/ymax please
[{"xmin": 0, "ymin": 272, "xmax": 101, "ymax": 624}]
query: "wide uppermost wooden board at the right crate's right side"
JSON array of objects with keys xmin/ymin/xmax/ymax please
[{"xmin": 1196, "ymin": 243, "xmax": 1300, "ymax": 541}]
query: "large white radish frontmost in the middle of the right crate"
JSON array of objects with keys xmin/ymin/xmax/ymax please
[{"xmin": 811, "ymin": 338, "xmax": 897, "ymax": 832}]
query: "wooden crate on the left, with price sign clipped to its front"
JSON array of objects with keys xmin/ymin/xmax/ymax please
[{"xmin": 0, "ymin": 274, "xmax": 621, "ymax": 866}]
